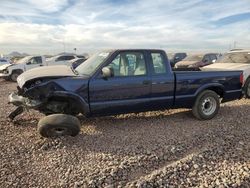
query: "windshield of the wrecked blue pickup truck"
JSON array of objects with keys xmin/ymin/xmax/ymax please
[{"xmin": 75, "ymin": 52, "xmax": 110, "ymax": 75}]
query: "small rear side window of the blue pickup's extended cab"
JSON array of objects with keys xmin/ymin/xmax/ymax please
[{"xmin": 151, "ymin": 53, "xmax": 166, "ymax": 74}]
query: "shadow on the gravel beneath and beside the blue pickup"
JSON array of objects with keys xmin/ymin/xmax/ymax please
[{"xmin": 56, "ymin": 105, "xmax": 250, "ymax": 154}]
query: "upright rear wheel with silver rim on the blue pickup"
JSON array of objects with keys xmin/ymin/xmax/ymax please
[{"xmin": 192, "ymin": 90, "xmax": 220, "ymax": 120}]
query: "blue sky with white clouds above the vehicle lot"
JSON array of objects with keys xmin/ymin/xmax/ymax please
[{"xmin": 0, "ymin": 0, "xmax": 250, "ymax": 54}]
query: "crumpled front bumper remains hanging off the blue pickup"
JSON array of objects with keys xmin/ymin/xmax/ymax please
[{"xmin": 8, "ymin": 92, "xmax": 42, "ymax": 120}]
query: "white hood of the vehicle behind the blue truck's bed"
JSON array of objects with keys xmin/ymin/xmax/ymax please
[{"xmin": 201, "ymin": 63, "xmax": 250, "ymax": 71}]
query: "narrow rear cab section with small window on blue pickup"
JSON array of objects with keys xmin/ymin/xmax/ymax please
[{"xmin": 149, "ymin": 51, "xmax": 175, "ymax": 110}]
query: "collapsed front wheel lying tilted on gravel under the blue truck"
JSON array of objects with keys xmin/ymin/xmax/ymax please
[{"xmin": 38, "ymin": 114, "xmax": 80, "ymax": 138}]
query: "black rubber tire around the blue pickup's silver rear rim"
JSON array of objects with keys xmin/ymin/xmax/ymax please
[{"xmin": 192, "ymin": 90, "xmax": 220, "ymax": 120}]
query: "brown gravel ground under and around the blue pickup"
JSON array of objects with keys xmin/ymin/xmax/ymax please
[{"xmin": 0, "ymin": 80, "xmax": 250, "ymax": 187}]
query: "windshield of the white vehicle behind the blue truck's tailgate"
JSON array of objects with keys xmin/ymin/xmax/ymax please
[{"xmin": 216, "ymin": 52, "xmax": 250, "ymax": 64}]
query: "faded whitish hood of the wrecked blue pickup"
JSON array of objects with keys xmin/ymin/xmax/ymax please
[{"xmin": 17, "ymin": 65, "xmax": 77, "ymax": 88}]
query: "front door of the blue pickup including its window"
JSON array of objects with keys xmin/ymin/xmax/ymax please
[{"xmin": 89, "ymin": 51, "xmax": 151, "ymax": 115}]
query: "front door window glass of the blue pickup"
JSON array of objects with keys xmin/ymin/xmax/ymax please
[{"xmin": 109, "ymin": 52, "xmax": 146, "ymax": 77}]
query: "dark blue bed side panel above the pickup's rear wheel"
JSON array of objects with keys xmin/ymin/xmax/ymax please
[{"xmin": 175, "ymin": 71, "xmax": 242, "ymax": 108}]
